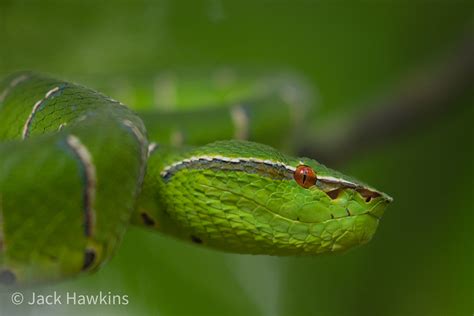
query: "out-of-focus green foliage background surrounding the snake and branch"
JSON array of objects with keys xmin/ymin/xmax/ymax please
[{"xmin": 0, "ymin": 0, "xmax": 474, "ymax": 315}]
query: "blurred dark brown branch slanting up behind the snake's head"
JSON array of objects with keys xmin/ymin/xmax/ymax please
[{"xmin": 299, "ymin": 33, "xmax": 474, "ymax": 166}]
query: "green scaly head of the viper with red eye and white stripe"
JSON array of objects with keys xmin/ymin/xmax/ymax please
[{"xmin": 149, "ymin": 141, "xmax": 392, "ymax": 255}]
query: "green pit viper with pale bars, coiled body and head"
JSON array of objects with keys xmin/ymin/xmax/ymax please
[{"xmin": 0, "ymin": 72, "xmax": 392, "ymax": 286}]
